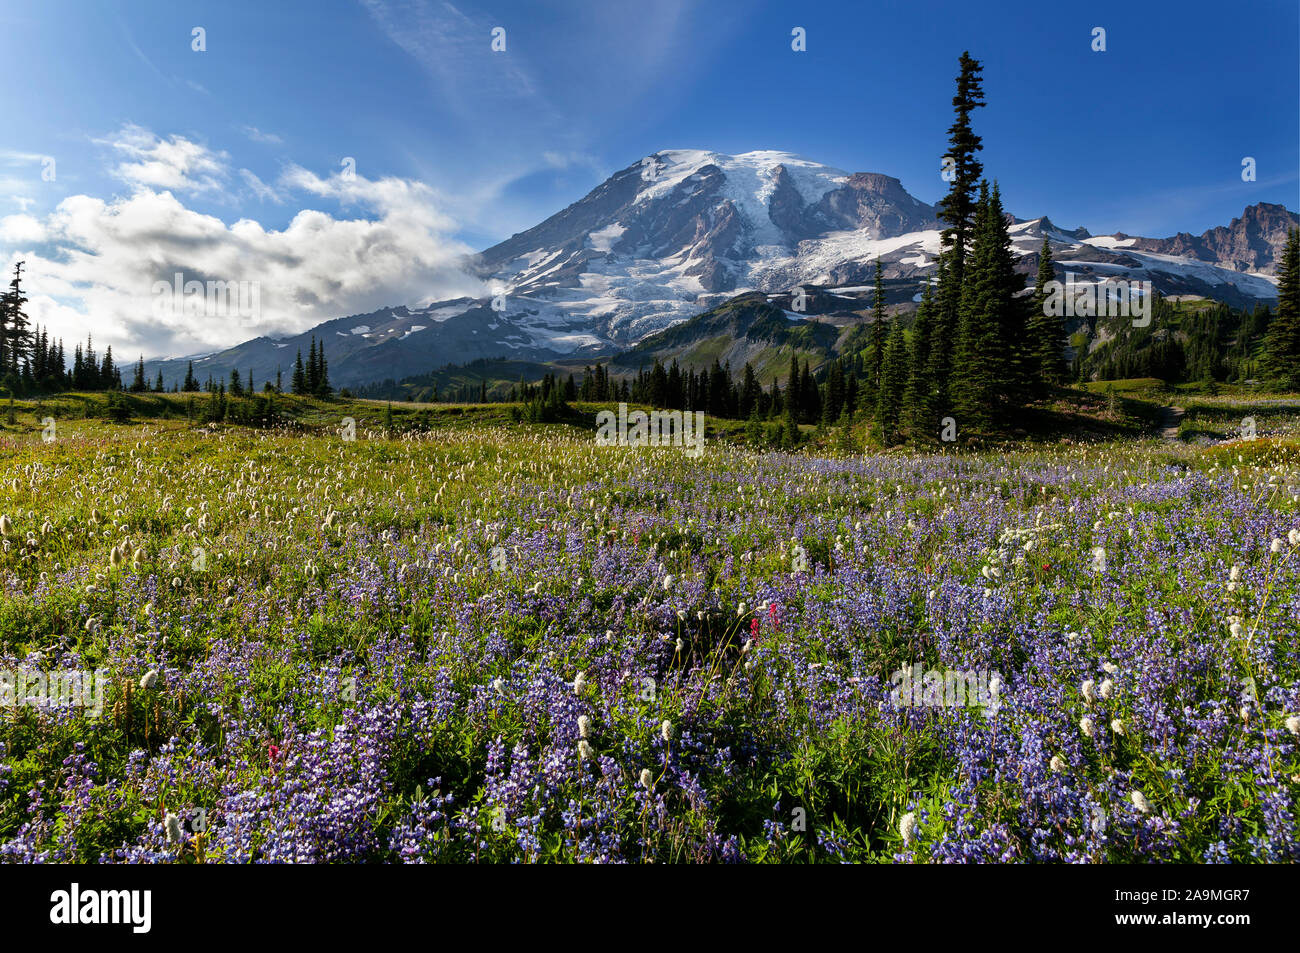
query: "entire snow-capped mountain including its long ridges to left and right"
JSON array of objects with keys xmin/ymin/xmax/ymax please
[{"xmin": 148, "ymin": 150, "xmax": 1300, "ymax": 385}]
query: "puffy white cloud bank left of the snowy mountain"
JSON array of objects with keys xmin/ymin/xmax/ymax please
[{"xmin": 0, "ymin": 130, "xmax": 486, "ymax": 356}]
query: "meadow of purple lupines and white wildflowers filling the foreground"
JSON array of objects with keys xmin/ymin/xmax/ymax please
[{"xmin": 0, "ymin": 404, "xmax": 1300, "ymax": 863}]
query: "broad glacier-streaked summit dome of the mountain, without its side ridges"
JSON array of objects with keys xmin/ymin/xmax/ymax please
[{"xmin": 477, "ymin": 150, "xmax": 937, "ymax": 346}]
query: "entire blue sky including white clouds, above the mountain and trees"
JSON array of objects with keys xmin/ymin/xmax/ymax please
[{"xmin": 0, "ymin": 0, "xmax": 1300, "ymax": 354}]
